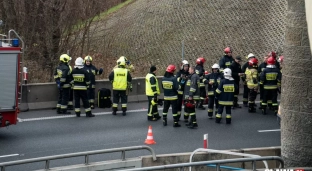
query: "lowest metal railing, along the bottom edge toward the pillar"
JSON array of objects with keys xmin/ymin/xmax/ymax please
[{"xmin": 123, "ymin": 156, "xmax": 284, "ymax": 171}]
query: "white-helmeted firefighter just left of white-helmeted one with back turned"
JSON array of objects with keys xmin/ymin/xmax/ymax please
[{"xmin": 204, "ymin": 64, "xmax": 223, "ymax": 119}]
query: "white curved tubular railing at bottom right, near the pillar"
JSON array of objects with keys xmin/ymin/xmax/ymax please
[{"xmin": 189, "ymin": 148, "xmax": 269, "ymax": 171}]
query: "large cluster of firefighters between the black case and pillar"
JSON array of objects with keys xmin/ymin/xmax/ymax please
[{"xmin": 146, "ymin": 47, "xmax": 283, "ymax": 128}]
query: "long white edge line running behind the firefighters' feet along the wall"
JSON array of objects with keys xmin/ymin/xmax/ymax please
[{"xmin": 18, "ymin": 101, "xmax": 278, "ymax": 122}]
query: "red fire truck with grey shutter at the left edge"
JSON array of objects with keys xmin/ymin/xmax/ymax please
[{"xmin": 0, "ymin": 30, "xmax": 24, "ymax": 127}]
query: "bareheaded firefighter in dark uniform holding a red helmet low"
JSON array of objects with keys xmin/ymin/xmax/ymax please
[{"xmin": 184, "ymin": 66, "xmax": 200, "ymax": 129}]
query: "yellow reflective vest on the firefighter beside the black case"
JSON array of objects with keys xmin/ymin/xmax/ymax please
[{"xmin": 113, "ymin": 68, "xmax": 128, "ymax": 90}]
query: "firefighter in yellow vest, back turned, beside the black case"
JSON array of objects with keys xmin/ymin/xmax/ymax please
[{"xmin": 109, "ymin": 59, "xmax": 132, "ymax": 116}]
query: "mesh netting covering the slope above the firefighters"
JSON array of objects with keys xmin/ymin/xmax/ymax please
[{"xmin": 86, "ymin": 0, "xmax": 287, "ymax": 76}]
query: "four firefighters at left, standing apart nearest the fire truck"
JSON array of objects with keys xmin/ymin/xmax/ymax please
[{"xmin": 54, "ymin": 54, "xmax": 134, "ymax": 117}]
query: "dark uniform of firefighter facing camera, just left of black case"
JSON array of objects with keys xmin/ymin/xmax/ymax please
[{"xmin": 84, "ymin": 64, "xmax": 102, "ymax": 108}]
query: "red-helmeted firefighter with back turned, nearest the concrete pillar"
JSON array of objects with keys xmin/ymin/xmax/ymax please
[{"xmin": 260, "ymin": 56, "xmax": 282, "ymax": 115}]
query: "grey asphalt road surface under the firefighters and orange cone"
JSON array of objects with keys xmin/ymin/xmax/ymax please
[{"xmin": 0, "ymin": 95, "xmax": 281, "ymax": 171}]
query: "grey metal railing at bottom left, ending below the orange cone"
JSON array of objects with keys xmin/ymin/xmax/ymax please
[{"xmin": 0, "ymin": 146, "xmax": 157, "ymax": 171}]
